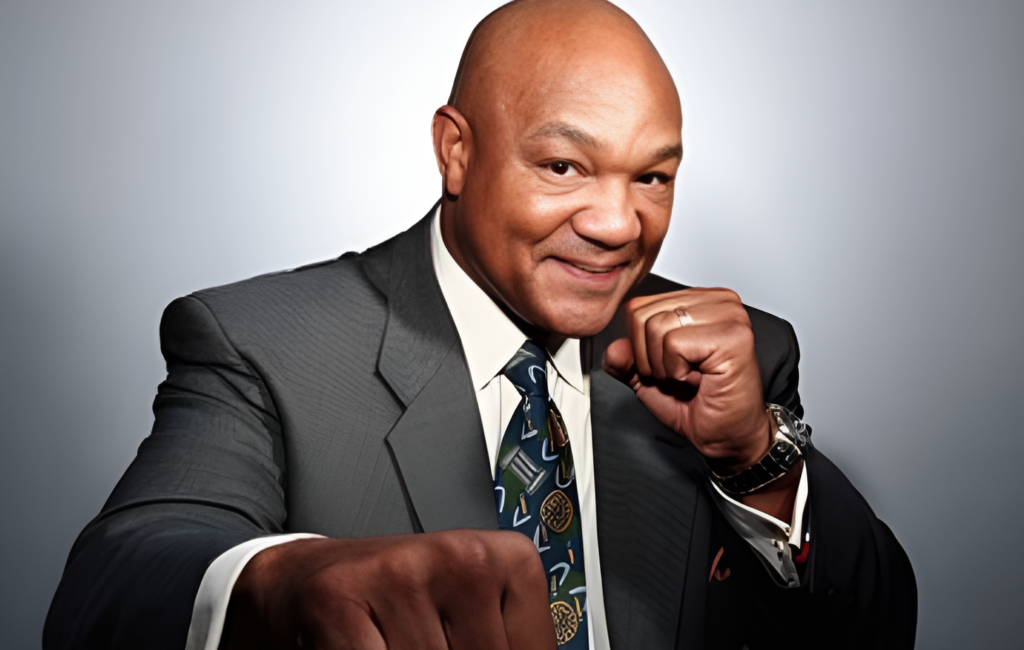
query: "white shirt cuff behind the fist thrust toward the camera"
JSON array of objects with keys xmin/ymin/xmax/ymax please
[{"xmin": 185, "ymin": 532, "xmax": 323, "ymax": 650}]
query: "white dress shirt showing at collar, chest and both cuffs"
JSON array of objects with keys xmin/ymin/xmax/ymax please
[{"xmin": 185, "ymin": 208, "xmax": 807, "ymax": 650}]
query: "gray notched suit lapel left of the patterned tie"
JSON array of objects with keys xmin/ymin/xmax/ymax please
[{"xmin": 366, "ymin": 210, "xmax": 498, "ymax": 531}]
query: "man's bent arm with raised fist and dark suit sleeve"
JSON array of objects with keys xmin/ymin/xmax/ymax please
[{"xmin": 605, "ymin": 290, "xmax": 916, "ymax": 648}]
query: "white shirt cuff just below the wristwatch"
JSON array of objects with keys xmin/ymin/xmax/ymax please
[{"xmin": 711, "ymin": 463, "xmax": 810, "ymax": 588}]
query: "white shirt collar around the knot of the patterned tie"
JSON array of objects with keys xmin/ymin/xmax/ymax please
[{"xmin": 430, "ymin": 206, "xmax": 584, "ymax": 392}]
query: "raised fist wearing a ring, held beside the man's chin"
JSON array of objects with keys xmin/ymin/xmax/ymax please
[{"xmin": 604, "ymin": 289, "xmax": 771, "ymax": 472}]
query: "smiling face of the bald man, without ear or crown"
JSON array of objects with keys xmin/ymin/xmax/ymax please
[{"xmin": 444, "ymin": 26, "xmax": 682, "ymax": 337}]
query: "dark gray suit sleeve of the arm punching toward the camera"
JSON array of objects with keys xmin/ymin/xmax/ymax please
[{"xmin": 43, "ymin": 297, "xmax": 286, "ymax": 649}]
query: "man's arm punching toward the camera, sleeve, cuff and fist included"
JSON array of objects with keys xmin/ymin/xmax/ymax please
[{"xmin": 44, "ymin": 297, "xmax": 555, "ymax": 650}]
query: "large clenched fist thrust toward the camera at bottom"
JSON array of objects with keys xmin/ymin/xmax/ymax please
[{"xmin": 221, "ymin": 530, "xmax": 556, "ymax": 650}]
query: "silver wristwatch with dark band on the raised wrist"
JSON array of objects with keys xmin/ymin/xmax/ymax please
[{"xmin": 709, "ymin": 404, "xmax": 811, "ymax": 496}]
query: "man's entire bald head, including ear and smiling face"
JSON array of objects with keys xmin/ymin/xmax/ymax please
[{"xmin": 433, "ymin": 0, "xmax": 682, "ymax": 337}]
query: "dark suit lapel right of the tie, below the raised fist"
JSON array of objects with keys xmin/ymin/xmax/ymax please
[{"xmin": 591, "ymin": 370, "xmax": 707, "ymax": 650}]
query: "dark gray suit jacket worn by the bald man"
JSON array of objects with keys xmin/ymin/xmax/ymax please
[{"xmin": 44, "ymin": 208, "xmax": 915, "ymax": 650}]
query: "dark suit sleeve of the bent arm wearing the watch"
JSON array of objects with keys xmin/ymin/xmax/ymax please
[{"xmin": 707, "ymin": 310, "xmax": 918, "ymax": 650}]
